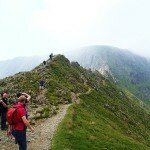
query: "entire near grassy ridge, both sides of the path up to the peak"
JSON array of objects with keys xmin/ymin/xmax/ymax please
[{"xmin": 0, "ymin": 55, "xmax": 150, "ymax": 150}]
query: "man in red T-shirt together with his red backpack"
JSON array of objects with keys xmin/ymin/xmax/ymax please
[{"xmin": 7, "ymin": 95, "xmax": 34, "ymax": 150}]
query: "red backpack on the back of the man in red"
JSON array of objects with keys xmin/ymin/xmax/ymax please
[{"xmin": 6, "ymin": 106, "xmax": 18, "ymax": 125}]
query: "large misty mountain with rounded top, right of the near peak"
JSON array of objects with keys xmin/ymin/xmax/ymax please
[{"xmin": 66, "ymin": 46, "xmax": 150, "ymax": 100}]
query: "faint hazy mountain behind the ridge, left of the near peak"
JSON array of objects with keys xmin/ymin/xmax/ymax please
[{"xmin": 0, "ymin": 55, "xmax": 48, "ymax": 79}]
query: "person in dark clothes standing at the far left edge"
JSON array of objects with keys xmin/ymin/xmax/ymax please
[{"xmin": 0, "ymin": 92, "xmax": 9, "ymax": 130}]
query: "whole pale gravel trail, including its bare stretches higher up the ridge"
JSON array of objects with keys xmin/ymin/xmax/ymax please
[{"xmin": 0, "ymin": 72, "xmax": 92, "ymax": 150}]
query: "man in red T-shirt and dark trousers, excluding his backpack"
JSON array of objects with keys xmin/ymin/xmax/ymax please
[{"xmin": 12, "ymin": 95, "xmax": 34, "ymax": 150}]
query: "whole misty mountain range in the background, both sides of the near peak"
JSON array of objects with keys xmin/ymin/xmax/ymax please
[{"xmin": 0, "ymin": 45, "xmax": 150, "ymax": 102}]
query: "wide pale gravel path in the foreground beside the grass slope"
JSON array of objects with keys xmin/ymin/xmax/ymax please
[{"xmin": 0, "ymin": 104, "xmax": 70, "ymax": 150}]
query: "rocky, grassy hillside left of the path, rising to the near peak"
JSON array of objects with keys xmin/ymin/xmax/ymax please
[{"xmin": 0, "ymin": 55, "xmax": 103, "ymax": 119}]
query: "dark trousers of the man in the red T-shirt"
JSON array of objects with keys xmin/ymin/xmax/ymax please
[{"xmin": 12, "ymin": 130, "xmax": 27, "ymax": 150}]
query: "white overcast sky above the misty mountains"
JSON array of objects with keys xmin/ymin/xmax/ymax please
[{"xmin": 0, "ymin": 0, "xmax": 150, "ymax": 60}]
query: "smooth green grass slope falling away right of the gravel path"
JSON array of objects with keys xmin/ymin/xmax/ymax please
[{"xmin": 52, "ymin": 70, "xmax": 150, "ymax": 150}]
